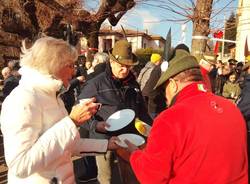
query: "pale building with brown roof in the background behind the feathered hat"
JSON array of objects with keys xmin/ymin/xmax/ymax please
[{"xmin": 98, "ymin": 28, "xmax": 165, "ymax": 52}]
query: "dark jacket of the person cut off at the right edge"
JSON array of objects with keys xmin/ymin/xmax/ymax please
[{"xmin": 237, "ymin": 74, "xmax": 250, "ymax": 130}]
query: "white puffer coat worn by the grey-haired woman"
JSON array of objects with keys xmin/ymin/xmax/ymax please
[{"xmin": 1, "ymin": 67, "xmax": 108, "ymax": 184}]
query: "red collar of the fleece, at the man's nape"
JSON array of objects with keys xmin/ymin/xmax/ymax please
[{"xmin": 169, "ymin": 82, "xmax": 207, "ymax": 107}]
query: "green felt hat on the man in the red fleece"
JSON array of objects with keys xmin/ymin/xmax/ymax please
[{"xmin": 154, "ymin": 49, "xmax": 200, "ymax": 89}]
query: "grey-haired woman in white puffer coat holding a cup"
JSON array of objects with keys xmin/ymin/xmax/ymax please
[{"xmin": 0, "ymin": 37, "xmax": 118, "ymax": 184}]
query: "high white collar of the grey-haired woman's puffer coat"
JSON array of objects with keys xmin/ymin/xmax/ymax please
[{"xmin": 19, "ymin": 66, "xmax": 63, "ymax": 94}]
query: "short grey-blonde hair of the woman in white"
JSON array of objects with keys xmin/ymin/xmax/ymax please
[{"xmin": 20, "ymin": 36, "xmax": 78, "ymax": 75}]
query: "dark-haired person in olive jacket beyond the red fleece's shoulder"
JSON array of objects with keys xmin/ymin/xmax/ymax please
[{"xmin": 222, "ymin": 72, "xmax": 241, "ymax": 103}]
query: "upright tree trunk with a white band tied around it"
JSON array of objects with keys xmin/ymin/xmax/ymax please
[{"xmin": 191, "ymin": 0, "xmax": 213, "ymax": 57}]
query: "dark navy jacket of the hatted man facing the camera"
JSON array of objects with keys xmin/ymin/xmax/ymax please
[{"xmin": 79, "ymin": 65, "xmax": 152, "ymax": 138}]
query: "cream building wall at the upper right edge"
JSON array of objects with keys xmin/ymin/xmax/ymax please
[{"xmin": 235, "ymin": 0, "xmax": 250, "ymax": 61}]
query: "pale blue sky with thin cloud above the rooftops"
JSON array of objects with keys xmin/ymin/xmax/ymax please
[{"xmin": 86, "ymin": 0, "xmax": 238, "ymax": 46}]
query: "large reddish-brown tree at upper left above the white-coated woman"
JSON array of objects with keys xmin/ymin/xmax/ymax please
[{"xmin": 0, "ymin": 0, "xmax": 136, "ymax": 62}]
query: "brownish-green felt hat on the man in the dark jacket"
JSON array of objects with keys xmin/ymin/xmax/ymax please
[{"xmin": 109, "ymin": 40, "xmax": 139, "ymax": 65}]
